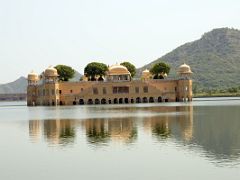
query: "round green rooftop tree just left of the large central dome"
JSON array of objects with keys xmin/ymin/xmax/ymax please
[{"xmin": 84, "ymin": 62, "xmax": 108, "ymax": 81}]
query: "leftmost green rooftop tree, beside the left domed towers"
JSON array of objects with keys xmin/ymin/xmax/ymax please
[{"xmin": 55, "ymin": 65, "xmax": 75, "ymax": 81}]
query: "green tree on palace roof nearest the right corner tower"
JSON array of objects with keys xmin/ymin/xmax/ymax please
[{"xmin": 150, "ymin": 62, "xmax": 170, "ymax": 79}]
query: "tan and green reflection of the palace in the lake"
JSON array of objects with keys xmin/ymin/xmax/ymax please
[{"xmin": 29, "ymin": 106, "xmax": 193, "ymax": 145}]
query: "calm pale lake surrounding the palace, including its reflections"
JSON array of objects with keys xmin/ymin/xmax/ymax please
[{"xmin": 0, "ymin": 98, "xmax": 240, "ymax": 180}]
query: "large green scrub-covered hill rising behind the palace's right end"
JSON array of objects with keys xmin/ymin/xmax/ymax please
[{"xmin": 138, "ymin": 28, "xmax": 240, "ymax": 90}]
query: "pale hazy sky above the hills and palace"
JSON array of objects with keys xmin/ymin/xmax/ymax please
[{"xmin": 0, "ymin": 0, "xmax": 240, "ymax": 84}]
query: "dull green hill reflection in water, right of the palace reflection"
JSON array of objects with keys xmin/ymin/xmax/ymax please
[{"xmin": 194, "ymin": 106, "xmax": 240, "ymax": 162}]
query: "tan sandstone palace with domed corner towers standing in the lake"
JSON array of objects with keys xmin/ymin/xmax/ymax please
[{"xmin": 27, "ymin": 63, "xmax": 192, "ymax": 106}]
